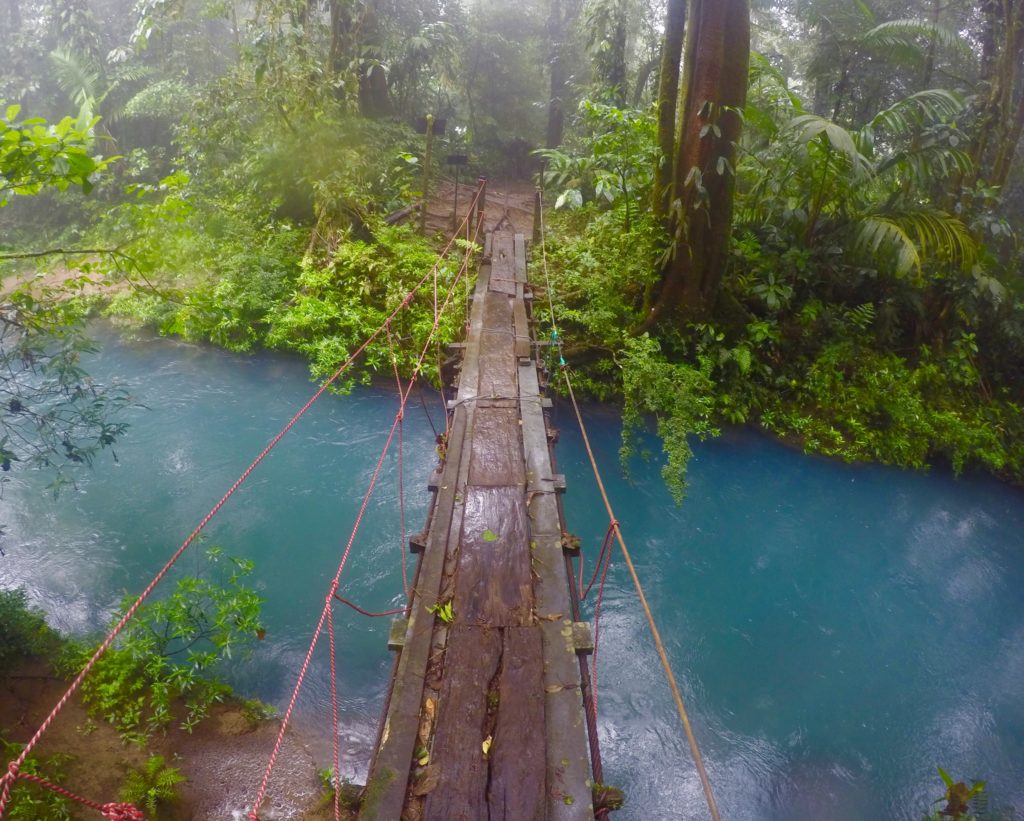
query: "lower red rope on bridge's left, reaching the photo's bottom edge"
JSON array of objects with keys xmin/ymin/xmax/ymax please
[{"xmin": 249, "ymin": 195, "xmax": 479, "ymax": 821}]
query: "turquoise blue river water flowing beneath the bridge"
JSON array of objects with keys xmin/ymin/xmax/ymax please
[{"xmin": 0, "ymin": 331, "xmax": 1024, "ymax": 821}]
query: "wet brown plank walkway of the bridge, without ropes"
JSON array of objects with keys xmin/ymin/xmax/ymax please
[{"xmin": 359, "ymin": 226, "xmax": 594, "ymax": 821}]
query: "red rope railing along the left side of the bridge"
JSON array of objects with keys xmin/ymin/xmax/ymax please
[{"xmin": 0, "ymin": 184, "xmax": 484, "ymax": 819}]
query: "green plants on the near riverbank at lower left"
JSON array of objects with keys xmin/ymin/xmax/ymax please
[{"xmin": 0, "ymin": 547, "xmax": 275, "ymax": 821}]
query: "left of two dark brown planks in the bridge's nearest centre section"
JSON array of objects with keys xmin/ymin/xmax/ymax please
[{"xmin": 423, "ymin": 625, "xmax": 502, "ymax": 821}]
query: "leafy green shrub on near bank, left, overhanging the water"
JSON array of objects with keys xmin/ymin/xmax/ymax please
[{"xmin": 63, "ymin": 548, "xmax": 265, "ymax": 744}]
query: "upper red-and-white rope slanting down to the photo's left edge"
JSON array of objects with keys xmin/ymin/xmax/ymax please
[{"xmin": 0, "ymin": 182, "xmax": 487, "ymax": 818}]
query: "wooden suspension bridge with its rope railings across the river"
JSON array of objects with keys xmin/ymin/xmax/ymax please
[{"xmin": 0, "ymin": 180, "xmax": 719, "ymax": 821}]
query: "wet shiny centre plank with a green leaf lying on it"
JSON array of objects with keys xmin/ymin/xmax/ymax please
[{"xmin": 454, "ymin": 487, "xmax": 534, "ymax": 626}]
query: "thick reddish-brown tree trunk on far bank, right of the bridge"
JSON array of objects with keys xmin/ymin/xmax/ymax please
[{"xmin": 643, "ymin": 0, "xmax": 751, "ymax": 330}]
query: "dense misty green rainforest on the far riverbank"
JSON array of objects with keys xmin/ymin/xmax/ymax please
[{"xmin": 0, "ymin": 0, "xmax": 1024, "ymax": 493}]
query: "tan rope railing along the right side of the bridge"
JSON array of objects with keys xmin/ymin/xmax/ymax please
[{"xmin": 538, "ymin": 190, "xmax": 721, "ymax": 821}]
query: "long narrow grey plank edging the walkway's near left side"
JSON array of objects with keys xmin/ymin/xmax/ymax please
[{"xmin": 359, "ymin": 406, "xmax": 473, "ymax": 821}]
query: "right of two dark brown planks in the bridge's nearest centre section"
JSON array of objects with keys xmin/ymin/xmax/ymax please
[{"xmin": 487, "ymin": 626, "xmax": 547, "ymax": 821}]
